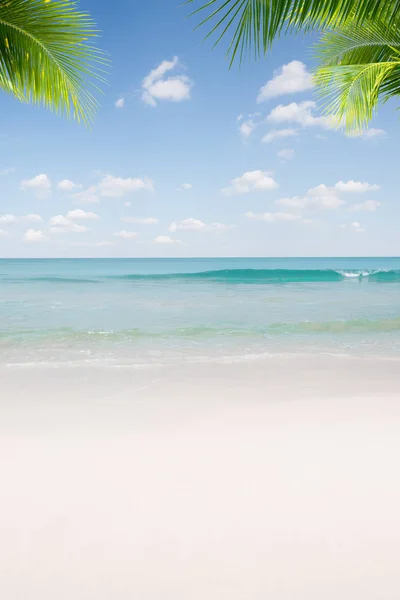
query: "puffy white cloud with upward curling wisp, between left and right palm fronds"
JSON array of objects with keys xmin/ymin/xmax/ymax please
[{"xmin": 142, "ymin": 56, "xmax": 193, "ymax": 106}]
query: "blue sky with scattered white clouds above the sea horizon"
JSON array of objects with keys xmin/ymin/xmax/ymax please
[{"xmin": 0, "ymin": 0, "xmax": 400, "ymax": 257}]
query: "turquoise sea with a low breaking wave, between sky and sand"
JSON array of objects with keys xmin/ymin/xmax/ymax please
[{"xmin": 0, "ymin": 258, "xmax": 400, "ymax": 366}]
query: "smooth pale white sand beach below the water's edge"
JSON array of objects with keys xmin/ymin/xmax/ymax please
[{"xmin": 0, "ymin": 357, "xmax": 400, "ymax": 600}]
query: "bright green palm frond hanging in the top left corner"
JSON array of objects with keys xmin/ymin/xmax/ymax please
[{"xmin": 0, "ymin": 0, "xmax": 107, "ymax": 124}]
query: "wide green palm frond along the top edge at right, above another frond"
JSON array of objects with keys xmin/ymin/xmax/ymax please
[{"xmin": 187, "ymin": 0, "xmax": 400, "ymax": 62}]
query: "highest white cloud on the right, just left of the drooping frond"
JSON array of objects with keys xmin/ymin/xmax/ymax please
[{"xmin": 257, "ymin": 60, "xmax": 314, "ymax": 103}]
